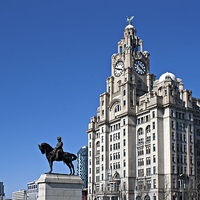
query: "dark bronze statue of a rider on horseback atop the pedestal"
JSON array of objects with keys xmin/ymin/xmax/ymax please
[{"xmin": 38, "ymin": 136, "xmax": 77, "ymax": 175}]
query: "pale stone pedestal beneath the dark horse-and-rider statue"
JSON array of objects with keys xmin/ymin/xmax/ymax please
[{"xmin": 37, "ymin": 173, "xmax": 83, "ymax": 200}]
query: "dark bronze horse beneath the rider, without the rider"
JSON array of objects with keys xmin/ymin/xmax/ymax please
[{"xmin": 38, "ymin": 143, "xmax": 77, "ymax": 175}]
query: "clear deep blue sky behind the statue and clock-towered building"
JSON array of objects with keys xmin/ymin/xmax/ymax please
[{"xmin": 0, "ymin": 0, "xmax": 200, "ymax": 198}]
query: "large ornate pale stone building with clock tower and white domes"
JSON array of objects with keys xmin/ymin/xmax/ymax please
[{"xmin": 87, "ymin": 21, "xmax": 200, "ymax": 200}]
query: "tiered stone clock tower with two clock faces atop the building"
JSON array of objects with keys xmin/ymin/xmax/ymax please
[{"xmin": 107, "ymin": 24, "xmax": 155, "ymax": 112}]
